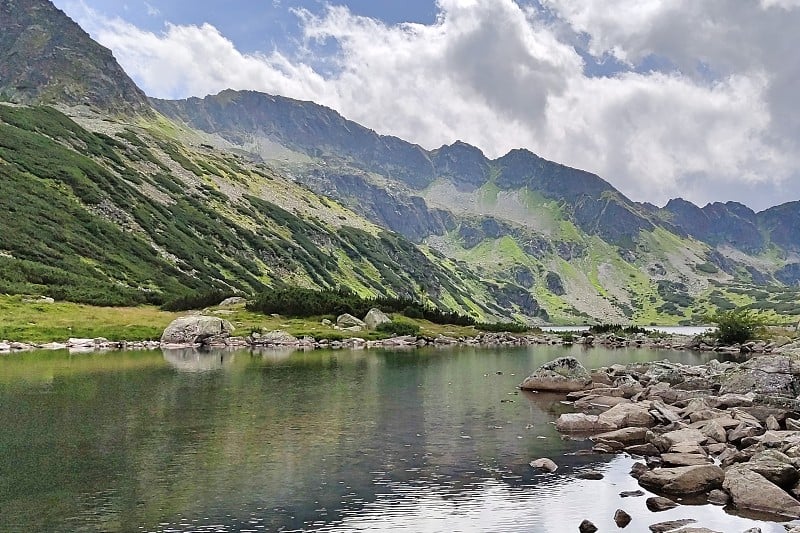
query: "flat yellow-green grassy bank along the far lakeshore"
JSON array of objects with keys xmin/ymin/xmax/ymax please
[{"xmin": 0, "ymin": 295, "xmax": 488, "ymax": 343}]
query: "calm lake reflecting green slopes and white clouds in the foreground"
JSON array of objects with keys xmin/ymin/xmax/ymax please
[{"xmin": 0, "ymin": 347, "xmax": 784, "ymax": 533}]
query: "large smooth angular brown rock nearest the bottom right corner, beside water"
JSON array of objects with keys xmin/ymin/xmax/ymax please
[{"xmin": 722, "ymin": 464, "xmax": 800, "ymax": 518}]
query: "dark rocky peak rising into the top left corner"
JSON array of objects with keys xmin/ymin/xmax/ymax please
[{"xmin": 0, "ymin": 0, "xmax": 151, "ymax": 114}]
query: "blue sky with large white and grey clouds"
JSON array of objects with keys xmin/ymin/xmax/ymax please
[{"xmin": 54, "ymin": 0, "xmax": 800, "ymax": 210}]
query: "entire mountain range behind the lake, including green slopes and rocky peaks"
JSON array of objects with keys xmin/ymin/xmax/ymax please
[{"xmin": 0, "ymin": 0, "xmax": 800, "ymax": 324}]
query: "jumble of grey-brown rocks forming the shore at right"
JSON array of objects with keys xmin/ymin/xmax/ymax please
[{"xmin": 520, "ymin": 341, "xmax": 800, "ymax": 533}]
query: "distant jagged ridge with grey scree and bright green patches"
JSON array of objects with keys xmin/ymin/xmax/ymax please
[{"xmin": 151, "ymin": 90, "xmax": 800, "ymax": 323}]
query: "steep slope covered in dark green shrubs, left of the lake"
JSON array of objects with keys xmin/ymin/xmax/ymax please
[{"xmin": 0, "ymin": 105, "xmax": 506, "ymax": 315}]
